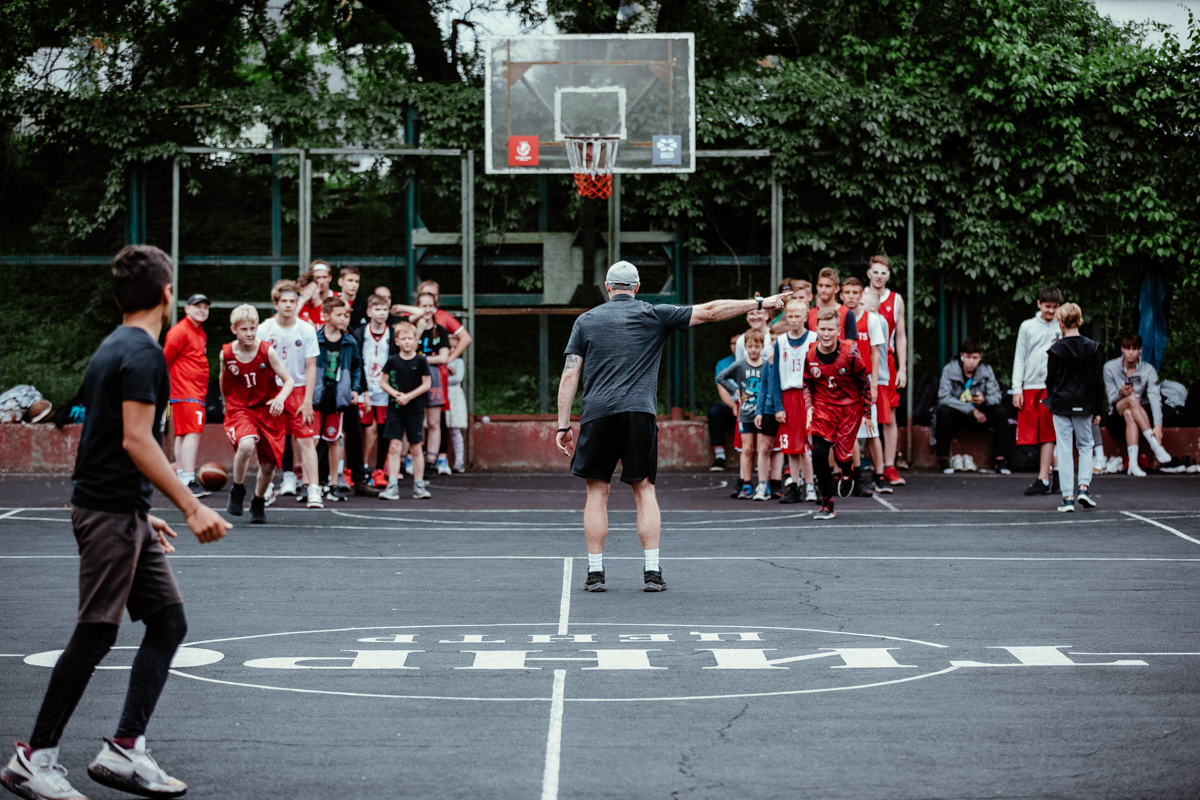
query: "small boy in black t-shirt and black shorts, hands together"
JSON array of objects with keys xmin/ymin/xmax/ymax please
[{"xmin": 379, "ymin": 323, "xmax": 433, "ymax": 500}]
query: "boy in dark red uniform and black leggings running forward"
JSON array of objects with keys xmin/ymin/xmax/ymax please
[{"xmin": 804, "ymin": 308, "xmax": 871, "ymax": 519}]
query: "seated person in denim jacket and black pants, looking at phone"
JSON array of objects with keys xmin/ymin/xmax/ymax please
[{"xmin": 935, "ymin": 338, "xmax": 1009, "ymax": 475}]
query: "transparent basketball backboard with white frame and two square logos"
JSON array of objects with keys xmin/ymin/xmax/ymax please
[{"xmin": 484, "ymin": 34, "xmax": 696, "ymax": 174}]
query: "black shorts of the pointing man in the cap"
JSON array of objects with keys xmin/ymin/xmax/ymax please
[{"xmin": 571, "ymin": 411, "xmax": 659, "ymax": 483}]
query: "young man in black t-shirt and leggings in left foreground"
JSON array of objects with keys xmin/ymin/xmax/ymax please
[{"xmin": 0, "ymin": 245, "xmax": 232, "ymax": 799}]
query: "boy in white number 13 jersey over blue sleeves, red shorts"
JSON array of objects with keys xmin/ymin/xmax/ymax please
[{"xmin": 756, "ymin": 297, "xmax": 817, "ymax": 504}]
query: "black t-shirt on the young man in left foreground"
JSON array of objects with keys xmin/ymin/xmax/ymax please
[{"xmin": 71, "ymin": 325, "xmax": 170, "ymax": 517}]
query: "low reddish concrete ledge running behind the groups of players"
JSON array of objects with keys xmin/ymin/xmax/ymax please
[{"xmin": 7, "ymin": 415, "xmax": 1200, "ymax": 473}]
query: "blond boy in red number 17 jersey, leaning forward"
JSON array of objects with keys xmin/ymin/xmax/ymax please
[{"xmin": 220, "ymin": 305, "xmax": 295, "ymax": 524}]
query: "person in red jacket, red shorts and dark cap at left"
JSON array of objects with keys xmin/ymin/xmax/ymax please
[{"xmin": 162, "ymin": 294, "xmax": 211, "ymax": 498}]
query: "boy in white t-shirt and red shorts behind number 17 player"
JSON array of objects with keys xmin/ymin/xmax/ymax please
[{"xmin": 257, "ymin": 281, "xmax": 325, "ymax": 509}]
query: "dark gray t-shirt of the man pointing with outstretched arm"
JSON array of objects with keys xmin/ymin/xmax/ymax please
[{"xmin": 564, "ymin": 295, "xmax": 691, "ymax": 423}]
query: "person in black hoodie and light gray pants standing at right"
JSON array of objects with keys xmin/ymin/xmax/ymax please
[{"xmin": 1045, "ymin": 302, "xmax": 1105, "ymax": 511}]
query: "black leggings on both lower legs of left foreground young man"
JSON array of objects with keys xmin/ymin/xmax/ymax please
[{"xmin": 29, "ymin": 603, "xmax": 187, "ymax": 750}]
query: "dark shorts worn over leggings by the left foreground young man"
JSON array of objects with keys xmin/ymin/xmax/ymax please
[{"xmin": 71, "ymin": 506, "xmax": 184, "ymax": 625}]
